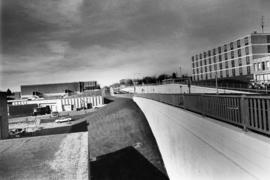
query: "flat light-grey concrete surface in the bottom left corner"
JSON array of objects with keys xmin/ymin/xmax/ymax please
[{"xmin": 0, "ymin": 132, "xmax": 88, "ymax": 180}]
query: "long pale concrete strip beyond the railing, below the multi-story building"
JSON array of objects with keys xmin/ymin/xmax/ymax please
[{"xmin": 122, "ymin": 84, "xmax": 251, "ymax": 94}]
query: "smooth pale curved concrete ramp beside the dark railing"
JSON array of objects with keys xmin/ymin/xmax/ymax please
[{"xmin": 134, "ymin": 97, "xmax": 270, "ymax": 180}]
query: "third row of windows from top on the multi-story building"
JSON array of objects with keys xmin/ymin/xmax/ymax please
[{"xmin": 192, "ymin": 56, "xmax": 250, "ymax": 72}]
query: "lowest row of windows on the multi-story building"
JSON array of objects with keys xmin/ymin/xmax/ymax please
[{"xmin": 193, "ymin": 66, "xmax": 251, "ymax": 80}]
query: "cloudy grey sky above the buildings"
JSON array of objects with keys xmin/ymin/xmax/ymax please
[{"xmin": 0, "ymin": 0, "xmax": 270, "ymax": 91}]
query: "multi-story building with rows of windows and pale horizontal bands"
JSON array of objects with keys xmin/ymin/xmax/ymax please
[{"xmin": 192, "ymin": 32, "xmax": 270, "ymax": 87}]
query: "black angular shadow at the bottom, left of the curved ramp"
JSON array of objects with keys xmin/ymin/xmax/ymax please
[{"xmin": 90, "ymin": 146, "xmax": 169, "ymax": 180}]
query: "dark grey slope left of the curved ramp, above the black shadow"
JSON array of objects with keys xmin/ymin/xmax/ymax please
[{"xmin": 85, "ymin": 98, "xmax": 166, "ymax": 177}]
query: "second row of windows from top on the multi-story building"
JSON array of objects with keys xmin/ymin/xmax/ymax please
[{"xmin": 192, "ymin": 48, "xmax": 249, "ymax": 68}]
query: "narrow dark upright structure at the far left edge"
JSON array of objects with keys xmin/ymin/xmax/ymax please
[{"xmin": 0, "ymin": 92, "xmax": 8, "ymax": 139}]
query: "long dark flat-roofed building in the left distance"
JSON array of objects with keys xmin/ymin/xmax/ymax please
[{"xmin": 21, "ymin": 81, "xmax": 100, "ymax": 98}]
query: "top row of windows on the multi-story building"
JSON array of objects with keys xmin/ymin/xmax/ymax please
[{"xmin": 192, "ymin": 37, "xmax": 249, "ymax": 61}]
